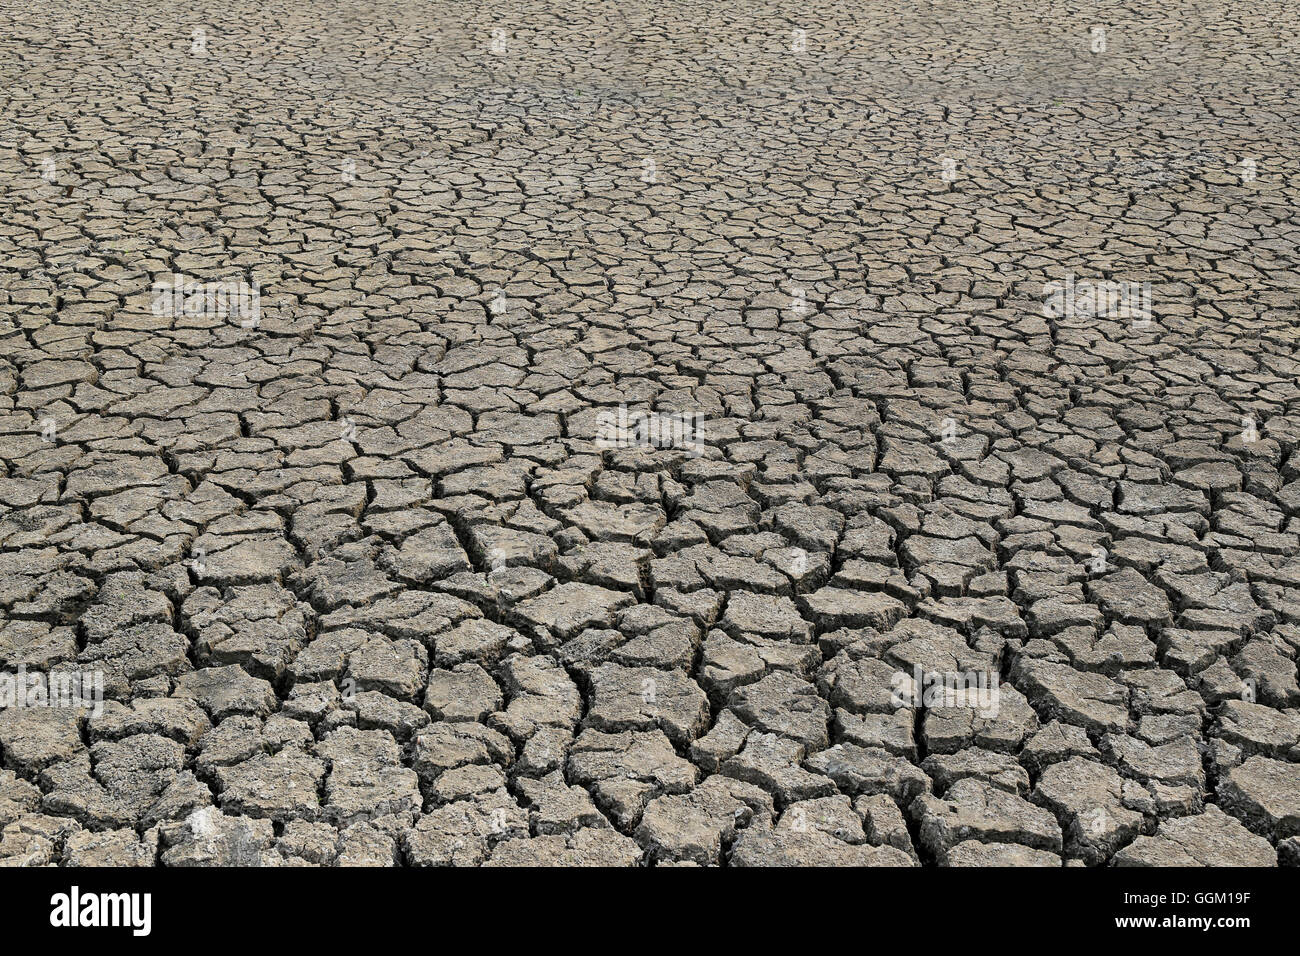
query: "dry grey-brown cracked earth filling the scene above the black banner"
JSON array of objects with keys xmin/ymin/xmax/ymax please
[{"xmin": 0, "ymin": 0, "xmax": 1300, "ymax": 866}]
